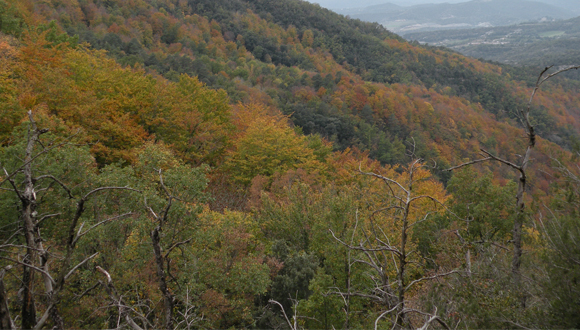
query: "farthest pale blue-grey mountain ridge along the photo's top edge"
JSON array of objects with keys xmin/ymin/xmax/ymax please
[{"xmin": 338, "ymin": 0, "xmax": 576, "ymax": 35}]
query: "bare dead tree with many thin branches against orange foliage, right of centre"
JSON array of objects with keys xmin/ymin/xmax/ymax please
[{"xmin": 330, "ymin": 159, "xmax": 458, "ymax": 329}]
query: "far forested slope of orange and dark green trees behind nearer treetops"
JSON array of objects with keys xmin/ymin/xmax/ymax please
[{"xmin": 3, "ymin": 0, "xmax": 580, "ymax": 174}]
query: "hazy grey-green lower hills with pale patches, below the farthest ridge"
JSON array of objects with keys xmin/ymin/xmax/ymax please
[{"xmin": 405, "ymin": 17, "xmax": 580, "ymax": 78}]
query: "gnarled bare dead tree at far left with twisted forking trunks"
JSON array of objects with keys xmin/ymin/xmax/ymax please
[{"xmin": 0, "ymin": 111, "xmax": 134, "ymax": 329}]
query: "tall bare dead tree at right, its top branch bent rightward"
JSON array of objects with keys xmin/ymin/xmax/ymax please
[{"xmin": 445, "ymin": 65, "xmax": 580, "ymax": 307}]
